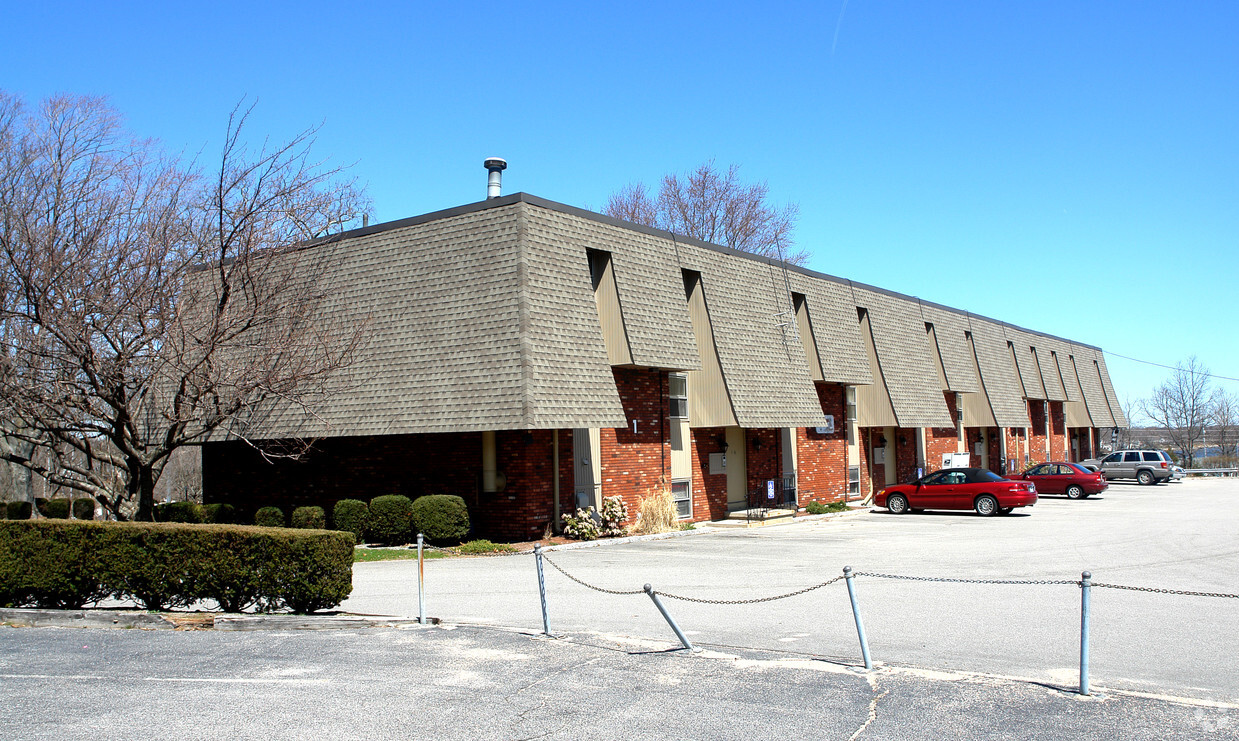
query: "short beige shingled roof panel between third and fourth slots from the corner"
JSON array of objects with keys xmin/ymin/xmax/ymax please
[{"xmin": 788, "ymin": 271, "xmax": 873, "ymax": 385}]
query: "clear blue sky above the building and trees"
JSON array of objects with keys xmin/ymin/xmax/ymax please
[{"xmin": 0, "ymin": 0, "xmax": 1239, "ymax": 421}]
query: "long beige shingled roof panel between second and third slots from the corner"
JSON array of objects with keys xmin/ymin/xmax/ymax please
[{"xmin": 676, "ymin": 242, "xmax": 826, "ymax": 428}]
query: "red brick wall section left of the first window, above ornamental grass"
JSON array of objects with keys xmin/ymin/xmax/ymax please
[{"xmin": 600, "ymin": 368, "xmax": 669, "ymax": 520}]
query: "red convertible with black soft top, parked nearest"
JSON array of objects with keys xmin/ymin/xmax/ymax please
[{"xmin": 873, "ymin": 468, "xmax": 1037, "ymax": 517}]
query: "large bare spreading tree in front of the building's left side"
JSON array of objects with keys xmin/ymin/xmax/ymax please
[{"xmin": 0, "ymin": 94, "xmax": 364, "ymax": 519}]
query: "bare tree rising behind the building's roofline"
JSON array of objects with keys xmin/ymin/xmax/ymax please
[{"xmin": 603, "ymin": 160, "xmax": 809, "ymax": 265}]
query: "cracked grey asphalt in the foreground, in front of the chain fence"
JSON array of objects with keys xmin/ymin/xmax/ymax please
[{"xmin": 0, "ymin": 627, "xmax": 1239, "ymax": 741}]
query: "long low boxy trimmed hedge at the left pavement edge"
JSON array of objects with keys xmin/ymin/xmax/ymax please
[{"xmin": 0, "ymin": 519, "xmax": 353, "ymax": 612}]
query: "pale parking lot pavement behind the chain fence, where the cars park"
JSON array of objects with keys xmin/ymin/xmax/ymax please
[{"xmin": 343, "ymin": 480, "xmax": 1239, "ymax": 703}]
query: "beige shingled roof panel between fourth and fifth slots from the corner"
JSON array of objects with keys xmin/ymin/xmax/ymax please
[{"xmin": 852, "ymin": 284, "xmax": 955, "ymax": 428}]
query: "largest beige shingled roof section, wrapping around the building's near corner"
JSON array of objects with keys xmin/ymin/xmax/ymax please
[{"xmin": 221, "ymin": 200, "xmax": 627, "ymax": 437}]
